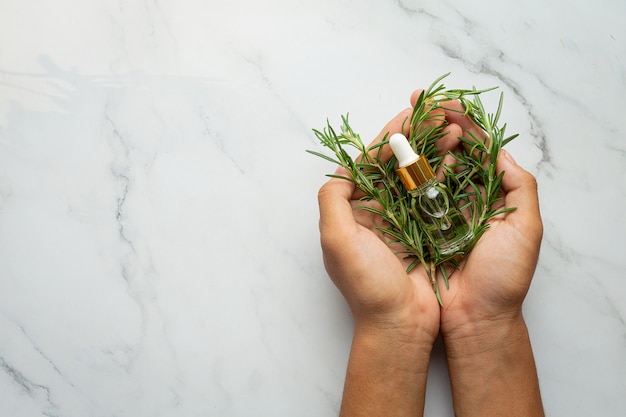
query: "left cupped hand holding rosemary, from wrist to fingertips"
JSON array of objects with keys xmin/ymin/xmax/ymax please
[{"xmin": 319, "ymin": 109, "xmax": 439, "ymax": 345}]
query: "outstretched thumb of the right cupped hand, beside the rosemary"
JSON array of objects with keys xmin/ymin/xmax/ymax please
[{"xmin": 497, "ymin": 149, "xmax": 543, "ymax": 243}]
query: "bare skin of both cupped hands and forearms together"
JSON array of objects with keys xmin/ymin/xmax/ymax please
[{"xmin": 318, "ymin": 91, "xmax": 543, "ymax": 416}]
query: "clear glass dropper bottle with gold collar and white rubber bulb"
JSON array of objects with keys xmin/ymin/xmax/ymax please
[{"xmin": 389, "ymin": 133, "xmax": 474, "ymax": 255}]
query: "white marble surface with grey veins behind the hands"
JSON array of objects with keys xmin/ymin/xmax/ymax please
[{"xmin": 0, "ymin": 0, "xmax": 626, "ymax": 417}]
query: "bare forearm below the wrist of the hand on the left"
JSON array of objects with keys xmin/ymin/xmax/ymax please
[{"xmin": 340, "ymin": 329, "xmax": 432, "ymax": 417}]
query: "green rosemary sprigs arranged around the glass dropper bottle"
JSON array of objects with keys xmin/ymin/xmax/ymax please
[{"xmin": 308, "ymin": 74, "xmax": 517, "ymax": 304}]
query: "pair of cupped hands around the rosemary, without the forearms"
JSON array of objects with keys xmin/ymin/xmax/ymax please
[{"xmin": 318, "ymin": 90, "xmax": 543, "ymax": 346}]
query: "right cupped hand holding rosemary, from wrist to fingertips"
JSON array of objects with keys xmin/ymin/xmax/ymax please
[{"xmin": 422, "ymin": 96, "xmax": 543, "ymax": 337}]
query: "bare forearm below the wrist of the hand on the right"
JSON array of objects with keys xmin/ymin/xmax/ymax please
[{"xmin": 444, "ymin": 316, "xmax": 544, "ymax": 417}]
